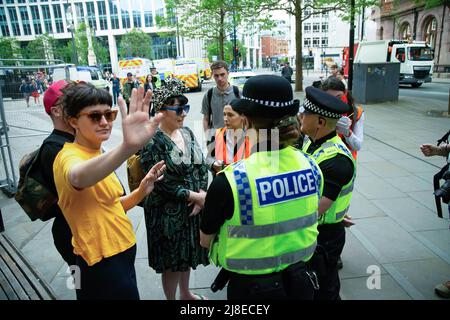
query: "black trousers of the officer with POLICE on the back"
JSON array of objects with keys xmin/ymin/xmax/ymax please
[{"xmin": 227, "ymin": 262, "xmax": 314, "ymax": 300}]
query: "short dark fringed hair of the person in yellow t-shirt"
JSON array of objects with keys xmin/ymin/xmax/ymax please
[{"xmin": 61, "ymin": 82, "xmax": 112, "ymax": 118}]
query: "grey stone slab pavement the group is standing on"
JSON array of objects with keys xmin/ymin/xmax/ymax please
[{"xmin": 0, "ymin": 80, "xmax": 450, "ymax": 299}]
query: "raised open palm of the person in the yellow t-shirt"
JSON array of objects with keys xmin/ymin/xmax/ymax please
[{"xmin": 118, "ymin": 87, "xmax": 162, "ymax": 153}]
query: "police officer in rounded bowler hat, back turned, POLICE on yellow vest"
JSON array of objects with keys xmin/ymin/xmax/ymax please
[{"xmin": 200, "ymin": 75, "xmax": 323, "ymax": 300}]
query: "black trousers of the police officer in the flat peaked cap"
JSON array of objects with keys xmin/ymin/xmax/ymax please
[{"xmin": 311, "ymin": 222, "xmax": 345, "ymax": 300}]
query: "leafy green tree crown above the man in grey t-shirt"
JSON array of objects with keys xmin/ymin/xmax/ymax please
[{"xmin": 162, "ymin": 0, "xmax": 274, "ymax": 60}]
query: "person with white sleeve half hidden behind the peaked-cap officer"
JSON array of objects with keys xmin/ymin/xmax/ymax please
[{"xmin": 322, "ymin": 77, "xmax": 364, "ymax": 160}]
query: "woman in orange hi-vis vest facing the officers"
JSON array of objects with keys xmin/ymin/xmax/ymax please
[{"xmin": 206, "ymin": 105, "xmax": 250, "ymax": 175}]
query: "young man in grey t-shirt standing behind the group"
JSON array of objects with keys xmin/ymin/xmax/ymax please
[{"xmin": 201, "ymin": 61, "xmax": 236, "ymax": 133}]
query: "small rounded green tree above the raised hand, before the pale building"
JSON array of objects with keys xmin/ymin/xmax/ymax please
[{"xmin": 118, "ymin": 29, "xmax": 153, "ymax": 59}]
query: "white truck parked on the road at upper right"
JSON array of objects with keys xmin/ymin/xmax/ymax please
[{"xmin": 354, "ymin": 40, "xmax": 434, "ymax": 88}]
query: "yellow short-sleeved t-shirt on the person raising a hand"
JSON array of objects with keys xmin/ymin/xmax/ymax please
[{"xmin": 53, "ymin": 143, "xmax": 136, "ymax": 266}]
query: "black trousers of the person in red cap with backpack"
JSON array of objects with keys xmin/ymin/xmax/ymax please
[{"xmin": 52, "ymin": 214, "xmax": 77, "ymax": 266}]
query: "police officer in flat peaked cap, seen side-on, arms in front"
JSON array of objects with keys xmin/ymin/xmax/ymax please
[{"xmin": 300, "ymin": 87, "xmax": 356, "ymax": 300}]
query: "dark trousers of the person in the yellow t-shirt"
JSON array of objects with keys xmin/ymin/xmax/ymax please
[{"xmin": 77, "ymin": 245, "xmax": 139, "ymax": 300}]
